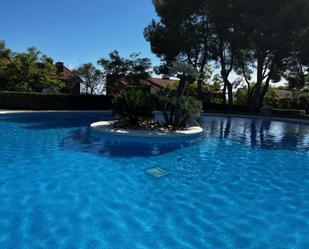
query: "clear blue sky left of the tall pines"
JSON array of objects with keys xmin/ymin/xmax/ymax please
[{"xmin": 0, "ymin": 0, "xmax": 159, "ymax": 67}]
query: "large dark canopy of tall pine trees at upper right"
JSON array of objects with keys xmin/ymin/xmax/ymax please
[{"xmin": 144, "ymin": 0, "xmax": 309, "ymax": 111}]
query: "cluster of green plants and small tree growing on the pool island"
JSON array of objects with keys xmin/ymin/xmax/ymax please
[{"xmin": 112, "ymin": 62, "xmax": 202, "ymax": 129}]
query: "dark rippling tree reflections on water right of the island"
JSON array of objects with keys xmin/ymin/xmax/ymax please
[{"xmin": 202, "ymin": 117, "xmax": 309, "ymax": 151}]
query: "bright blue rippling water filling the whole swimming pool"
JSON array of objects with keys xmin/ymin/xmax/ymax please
[{"xmin": 0, "ymin": 113, "xmax": 309, "ymax": 249}]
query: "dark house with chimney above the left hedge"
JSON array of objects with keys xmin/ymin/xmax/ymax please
[{"xmin": 55, "ymin": 62, "xmax": 82, "ymax": 95}]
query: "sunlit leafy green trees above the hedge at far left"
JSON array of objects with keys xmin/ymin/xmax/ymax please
[{"xmin": 0, "ymin": 42, "xmax": 64, "ymax": 93}]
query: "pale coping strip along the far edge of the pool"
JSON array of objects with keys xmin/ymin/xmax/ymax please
[{"xmin": 0, "ymin": 109, "xmax": 309, "ymax": 125}]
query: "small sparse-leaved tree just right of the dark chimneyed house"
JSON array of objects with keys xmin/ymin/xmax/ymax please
[{"xmin": 74, "ymin": 63, "xmax": 104, "ymax": 95}]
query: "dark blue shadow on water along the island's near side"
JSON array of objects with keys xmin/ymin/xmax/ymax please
[{"xmin": 60, "ymin": 128, "xmax": 202, "ymax": 157}]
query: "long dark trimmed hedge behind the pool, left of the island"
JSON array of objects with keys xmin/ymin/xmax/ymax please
[{"xmin": 0, "ymin": 92, "xmax": 111, "ymax": 110}]
